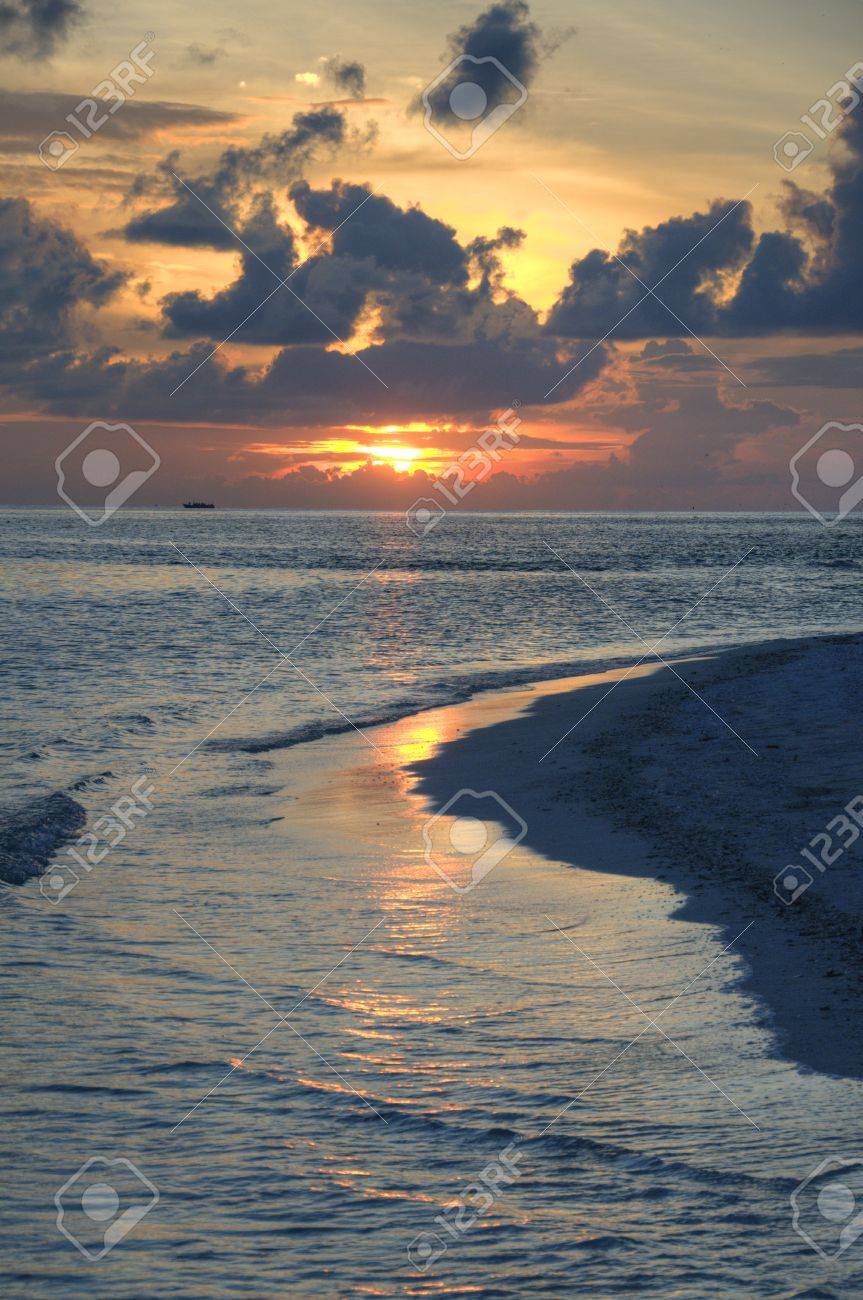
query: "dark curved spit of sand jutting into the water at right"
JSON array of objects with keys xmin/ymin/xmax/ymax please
[{"xmin": 411, "ymin": 634, "xmax": 863, "ymax": 1078}]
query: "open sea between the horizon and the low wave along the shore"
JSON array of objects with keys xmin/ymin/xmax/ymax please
[{"xmin": 0, "ymin": 510, "xmax": 863, "ymax": 802}]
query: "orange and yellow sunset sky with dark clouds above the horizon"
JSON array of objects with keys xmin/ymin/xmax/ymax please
[{"xmin": 0, "ymin": 0, "xmax": 863, "ymax": 510}]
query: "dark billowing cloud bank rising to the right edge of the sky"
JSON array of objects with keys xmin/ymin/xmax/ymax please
[{"xmin": 547, "ymin": 103, "xmax": 863, "ymax": 339}]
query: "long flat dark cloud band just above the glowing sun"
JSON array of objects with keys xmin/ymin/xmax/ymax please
[{"xmin": 14, "ymin": 330, "xmax": 607, "ymax": 426}]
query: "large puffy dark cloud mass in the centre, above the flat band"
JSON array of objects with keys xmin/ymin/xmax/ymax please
[{"xmin": 159, "ymin": 181, "xmax": 539, "ymax": 345}]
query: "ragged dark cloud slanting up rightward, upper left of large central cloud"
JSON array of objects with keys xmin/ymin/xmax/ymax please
[{"xmin": 123, "ymin": 108, "xmax": 346, "ymax": 248}]
